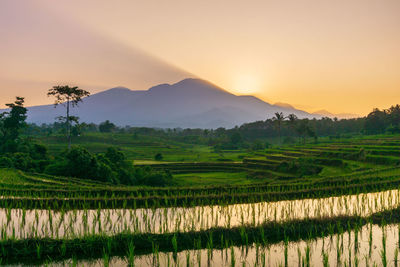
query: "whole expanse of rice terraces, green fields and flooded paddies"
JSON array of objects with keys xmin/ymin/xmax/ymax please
[{"xmin": 0, "ymin": 134, "xmax": 400, "ymax": 266}]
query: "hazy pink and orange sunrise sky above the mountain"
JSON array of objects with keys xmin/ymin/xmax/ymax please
[{"xmin": 0, "ymin": 0, "xmax": 400, "ymax": 115}]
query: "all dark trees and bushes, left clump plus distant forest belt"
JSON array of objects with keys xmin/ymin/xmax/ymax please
[{"xmin": 0, "ymin": 85, "xmax": 400, "ymax": 186}]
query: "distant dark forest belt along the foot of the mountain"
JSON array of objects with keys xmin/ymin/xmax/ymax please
[{"xmin": 24, "ymin": 105, "xmax": 400, "ymax": 148}]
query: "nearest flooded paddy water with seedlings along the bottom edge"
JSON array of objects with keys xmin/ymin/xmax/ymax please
[{"xmin": 10, "ymin": 225, "xmax": 400, "ymax": 266}]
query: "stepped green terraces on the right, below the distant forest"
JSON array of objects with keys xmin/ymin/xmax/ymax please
[{"xmin": 134, "ymin": 138, "xmax": 400, "ymax": 186}]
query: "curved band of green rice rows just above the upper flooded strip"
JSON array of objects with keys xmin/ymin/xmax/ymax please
[{"xmin": 0, "ymin": 167, "xmax": 400, "ymax": 210}]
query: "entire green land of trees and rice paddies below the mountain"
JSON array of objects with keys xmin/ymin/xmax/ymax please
[{"xmin": 0, "ymin": 94, "xmax": 400, "ymax": 266}]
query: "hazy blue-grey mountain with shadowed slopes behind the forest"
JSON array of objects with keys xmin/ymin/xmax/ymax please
[{"xmin": 22, "ymin": 79, "xmax": 321, "ymax": 128}]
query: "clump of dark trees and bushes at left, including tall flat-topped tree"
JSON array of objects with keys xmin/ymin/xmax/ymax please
[{"xmin": 0, "ymin": 86, "xmax": 172, "ymax": 186}]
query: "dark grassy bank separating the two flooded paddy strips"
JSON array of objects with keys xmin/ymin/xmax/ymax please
[{"xmin": 0, "ymin": 205, "xmax": 400, "ymax": 262}]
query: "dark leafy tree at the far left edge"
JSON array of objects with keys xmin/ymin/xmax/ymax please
[{"xmin": 0, "ymin": 96, "xmax": 27, "ymax": 152}]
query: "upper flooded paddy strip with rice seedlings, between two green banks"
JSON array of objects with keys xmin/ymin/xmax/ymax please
[{"xmin": 0, "ymin": 190, "xmax": 400, "ymax": 239}]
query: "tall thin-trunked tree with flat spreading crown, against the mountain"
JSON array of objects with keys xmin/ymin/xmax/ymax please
[{"xmin": 47, "ymin": 85, "xmax": 90, "ymax": 149}]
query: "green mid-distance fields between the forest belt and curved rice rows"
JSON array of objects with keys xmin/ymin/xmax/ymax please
[{"xmin": 32, "ymin": 133, "xmax": 400, "ymax": 188}]
